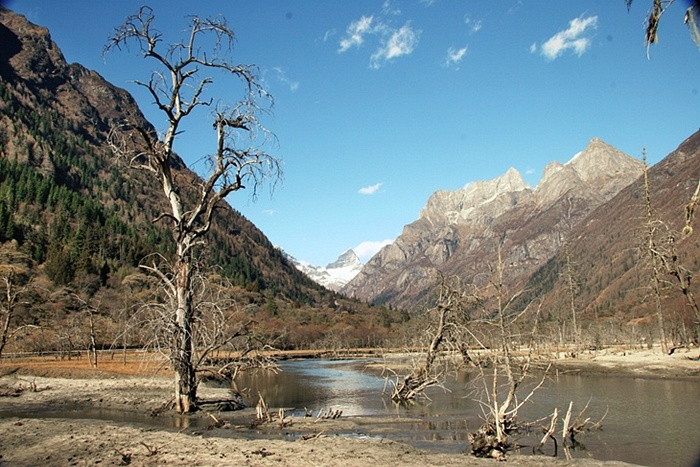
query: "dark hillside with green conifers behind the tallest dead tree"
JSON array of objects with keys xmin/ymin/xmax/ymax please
[{"xmin": 0, "ymin": 9, "xmax": 404, "ymax": 356}]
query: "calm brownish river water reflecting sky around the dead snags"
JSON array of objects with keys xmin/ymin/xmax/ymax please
[{"xmin": 237, "ymin": 360, "xmax": 700, "ymax": 466}]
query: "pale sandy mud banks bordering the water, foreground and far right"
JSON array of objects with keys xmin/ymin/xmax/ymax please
[{"xmin": 0, "ymin": 349, "xmax": 700, "ymax": 466}]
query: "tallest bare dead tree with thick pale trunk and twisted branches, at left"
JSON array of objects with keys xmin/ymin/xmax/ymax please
[{"xmin": 105, "ymin": 7, "xmax": 281, "ymax": 413}]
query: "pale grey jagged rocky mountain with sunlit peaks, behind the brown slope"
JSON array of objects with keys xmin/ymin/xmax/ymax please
[{"xmin": 342, "ymin": 138, "xmax": 642, "ymax": 309}]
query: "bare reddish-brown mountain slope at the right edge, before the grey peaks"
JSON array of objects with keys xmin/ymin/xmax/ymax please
[{"xmin": 530, "ymin": 131, "xmax": 700, "ymax": 326}]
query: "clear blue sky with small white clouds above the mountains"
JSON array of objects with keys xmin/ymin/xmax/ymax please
[{"xmin": 4, "ymin": 0, "xmax": 700, "ymax": 265}]
